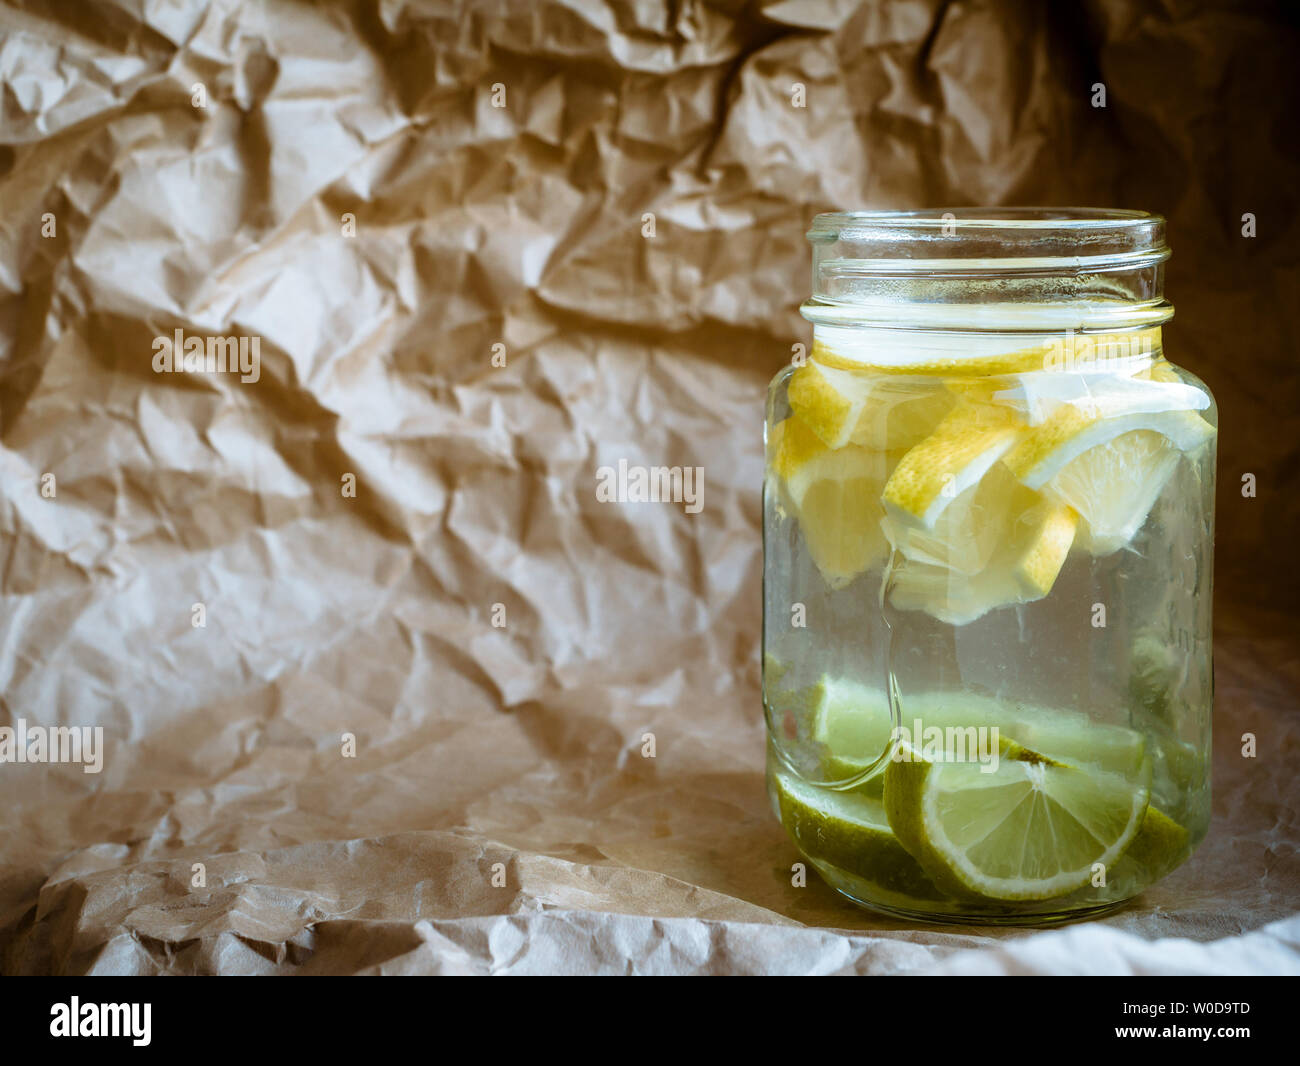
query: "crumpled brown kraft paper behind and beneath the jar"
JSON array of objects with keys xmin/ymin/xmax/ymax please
[{"xmin": 0, "ymin": 0, "xmax": 1300, "ymax": 974}]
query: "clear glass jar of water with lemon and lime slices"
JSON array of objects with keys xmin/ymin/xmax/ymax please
[{"xmin": 763, "ymin": 208, "xmax": 1217, "ymax": 923}]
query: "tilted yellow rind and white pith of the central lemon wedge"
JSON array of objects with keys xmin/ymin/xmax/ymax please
[{"xmin": 883, "ymin": 402, "xmax": 1022, "ymax": 529}]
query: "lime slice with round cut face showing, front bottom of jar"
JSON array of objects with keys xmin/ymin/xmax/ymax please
[{"xmin": 884, "ymin": 738, "xmax": 1149, "ymax": 900}]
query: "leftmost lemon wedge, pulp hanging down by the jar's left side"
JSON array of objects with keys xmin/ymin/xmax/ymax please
[{"xmin": 768, "ymin": 416, "xmax": 887, "ymax": 589}]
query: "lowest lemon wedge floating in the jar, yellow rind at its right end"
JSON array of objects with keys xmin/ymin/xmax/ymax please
[{"xmin": 889, "ymin": 501, "xmax": 1078, "ymax": 625}]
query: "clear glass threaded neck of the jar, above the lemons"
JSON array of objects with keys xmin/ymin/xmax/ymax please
[{"xmin": 801, "ymin": 208, "xmax": 1174, "ymax": 335}]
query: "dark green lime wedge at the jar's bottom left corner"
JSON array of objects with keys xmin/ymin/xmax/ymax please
[{"xmin": 774, "ymin": 774, "xmax": 943, "ymax": 902}]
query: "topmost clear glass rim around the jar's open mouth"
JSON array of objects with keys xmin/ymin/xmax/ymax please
[{"xmin": 807, "ymin": 207, "xmax": 1170, "ymax": 277}]
